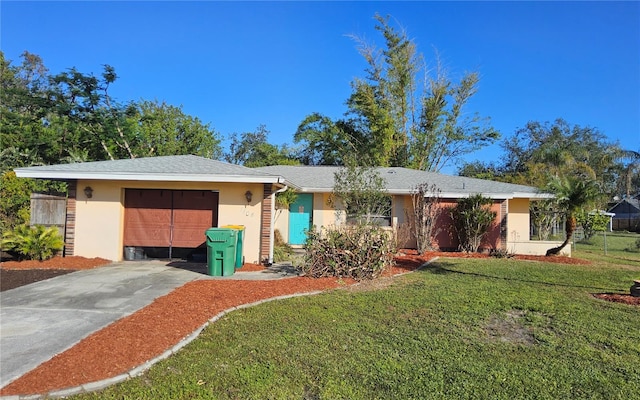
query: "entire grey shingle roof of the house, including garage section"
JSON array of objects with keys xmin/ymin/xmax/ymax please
[{"xmin": 15, "ymin": 155, "xmax": 552, "ymax": 199}]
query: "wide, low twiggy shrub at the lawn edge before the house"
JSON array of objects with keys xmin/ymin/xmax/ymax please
[{"xmin": 302, "ymin": 224, "xmax": 395, "ymax": 281}]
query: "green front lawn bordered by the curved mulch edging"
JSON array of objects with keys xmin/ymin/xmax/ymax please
[{"xmin": 76, "ymin": 238, "xmax": 640, "ymax": 399}]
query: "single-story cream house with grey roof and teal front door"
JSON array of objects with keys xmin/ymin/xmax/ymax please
[{"xmin": 15, "ymin": 155, "xmax": 570, "ymax": 263}]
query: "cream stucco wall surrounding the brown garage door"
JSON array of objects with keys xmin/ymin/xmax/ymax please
[{"xmin": 75, "ymin": 180, "xmax": 263, "ymax": 263}]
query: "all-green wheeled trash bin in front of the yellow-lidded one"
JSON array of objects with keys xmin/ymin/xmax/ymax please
[{"xmin": 205, "ymin": 228, "xmax": 238, "ymax": 276}]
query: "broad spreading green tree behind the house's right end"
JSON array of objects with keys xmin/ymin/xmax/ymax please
[{"xmin": 460, "ymin": 119, "xmax": 640, "ymax": 202}]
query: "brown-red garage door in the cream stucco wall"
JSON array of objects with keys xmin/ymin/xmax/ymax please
[{"xmin": 124, "ymin": 189, "xmax": 218, "ymax": 248}]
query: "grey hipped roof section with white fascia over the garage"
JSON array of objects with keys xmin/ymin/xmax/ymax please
[{"xmin": 15, "ymin": 155, "xmax": 283, "ymax": 183}]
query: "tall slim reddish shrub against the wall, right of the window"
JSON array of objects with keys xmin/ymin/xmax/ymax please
[{"xmin": 411, "ymin": 183, "xmax": 442, "ymax": 254}]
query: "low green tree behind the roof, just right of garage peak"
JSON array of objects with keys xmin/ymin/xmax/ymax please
[{"xmin": 225, "ymin": 125, "xmax": 300, "ymax": 168}]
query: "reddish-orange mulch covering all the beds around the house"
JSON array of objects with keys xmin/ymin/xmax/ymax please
[{"xmin": 0, "ymin": 251, "xmax": 636, "ymax": 396}]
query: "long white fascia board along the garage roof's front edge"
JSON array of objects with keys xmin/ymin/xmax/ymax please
[{"xmin": 15, "ymin": 169, "xmax": 284, "ymax": 183}]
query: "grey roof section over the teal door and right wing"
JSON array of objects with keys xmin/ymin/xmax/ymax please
[{"xmin": 256, "ymin": 165, "xmax": 552, "ymax": 199}]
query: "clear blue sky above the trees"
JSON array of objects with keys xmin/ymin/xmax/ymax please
[{"xmin": 0, "ymin": 0, "xmax": 640, "ymax": 172}]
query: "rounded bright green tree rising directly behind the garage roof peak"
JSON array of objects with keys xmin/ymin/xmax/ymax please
[{"xmin": 131, "ymin": 100, "xmax": 222, "ymax": 159}]
